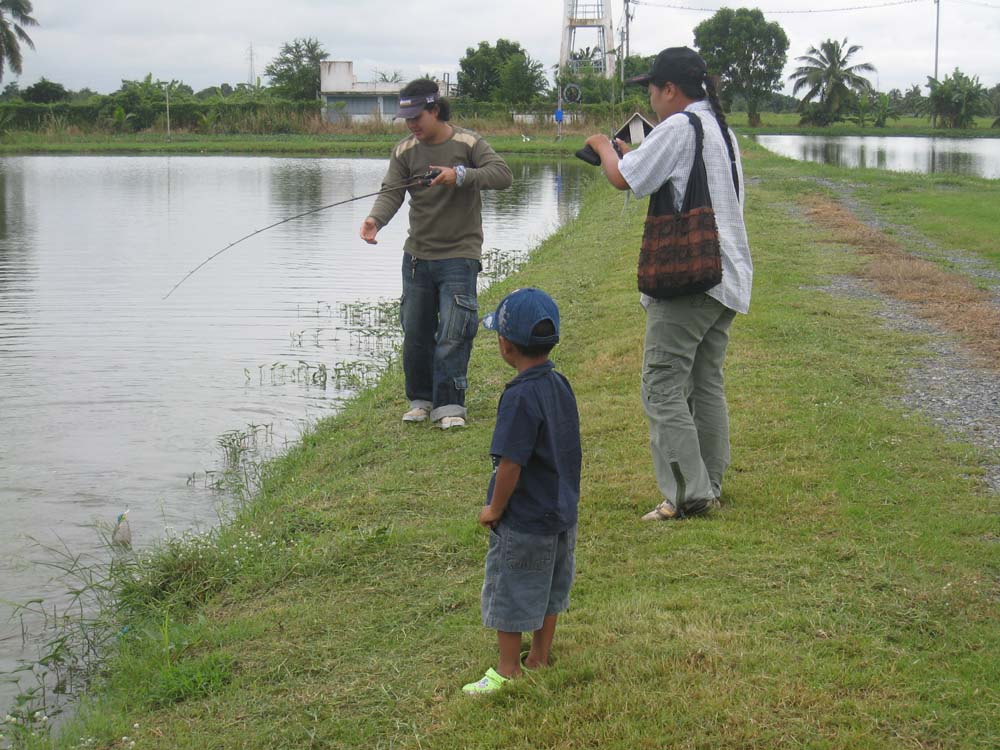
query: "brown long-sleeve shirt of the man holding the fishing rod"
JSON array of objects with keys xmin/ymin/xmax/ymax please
[{"xmin": 370, "ymin": 126, "xmax": 514, "ymax": 260}]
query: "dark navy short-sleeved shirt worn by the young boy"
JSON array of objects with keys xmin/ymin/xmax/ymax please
[{"xmin": 486, "ymin": 361, "xmax": 581, "ymax": 534}]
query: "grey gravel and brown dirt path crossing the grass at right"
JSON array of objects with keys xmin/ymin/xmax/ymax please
[{"xmin": 807, "ymin": 182, "xmax": 1000, "ymax": 492}]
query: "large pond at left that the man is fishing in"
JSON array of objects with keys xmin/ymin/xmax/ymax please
[{"xmin": 0, "ymin": 157, "xmax": 584, "ymax": 711}]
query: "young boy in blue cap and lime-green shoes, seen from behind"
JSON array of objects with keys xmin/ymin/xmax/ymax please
[{"xmin": 462, "ymin": 289, "xmax": 581, "ymax": 695}]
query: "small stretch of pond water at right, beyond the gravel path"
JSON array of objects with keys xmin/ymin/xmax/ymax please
[{"xmin": 754, "ymin": 135, "xmax": 1000, "ymax": 180}]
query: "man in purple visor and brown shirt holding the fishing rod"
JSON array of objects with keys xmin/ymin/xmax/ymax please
[{"xmin": 361, "ymin": 78, "xmax": 513, "ymax": 430}]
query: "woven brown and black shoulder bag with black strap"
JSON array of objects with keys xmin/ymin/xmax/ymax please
[{"xmin": 638, "ymin": 112, "xmax": 735, "ymax": 299}]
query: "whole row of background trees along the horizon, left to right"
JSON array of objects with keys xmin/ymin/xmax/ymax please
[{"xmin": 0, "ymin": 0, "xmax": 1000, "ymax": 132}]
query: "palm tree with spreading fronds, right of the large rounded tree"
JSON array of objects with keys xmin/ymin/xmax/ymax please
[{"xmin": 788, "ymin": 39, "xmax": 875, "ymax": 119}]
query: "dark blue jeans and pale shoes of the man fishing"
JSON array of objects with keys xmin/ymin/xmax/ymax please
[{"xmin": 399, "ymin": 253, "xmax": 482, "ymax": 422}]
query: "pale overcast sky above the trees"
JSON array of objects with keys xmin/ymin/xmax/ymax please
[{"xmin": 9, "ymin": 0, "xmax": 1000, "ymax": 93}]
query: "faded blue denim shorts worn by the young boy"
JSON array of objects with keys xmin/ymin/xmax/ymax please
[{"xmin": 482, "ymin": 520, "xmax": 576, "ymax": 633}]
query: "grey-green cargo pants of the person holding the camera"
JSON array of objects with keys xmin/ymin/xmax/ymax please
[{"xmin": 642, "ymin": 294, "xmax": 736, "ymax": 513}]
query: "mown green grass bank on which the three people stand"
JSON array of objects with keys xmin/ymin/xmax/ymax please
[{"xmin": 9, "ymin": 139, "xmax": 1000, "ymax": 750}]
